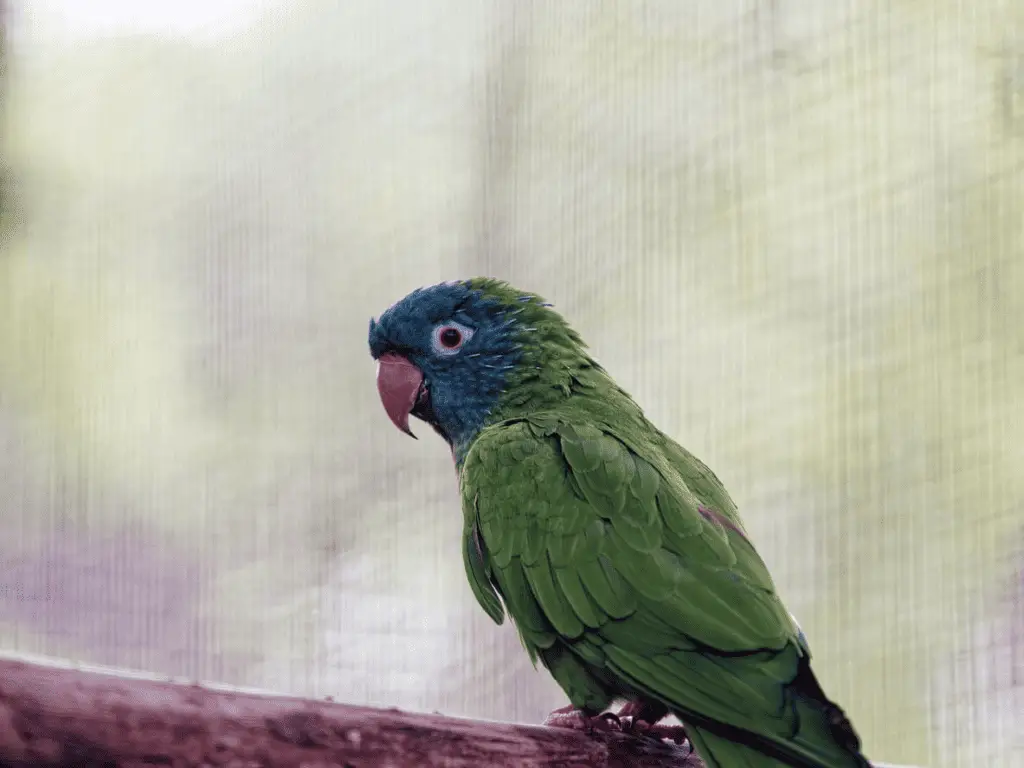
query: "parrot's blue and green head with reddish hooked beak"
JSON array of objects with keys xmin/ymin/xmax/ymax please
[{"xmin": 370, "ymin": 278, "xmax": 589, "ymax": 452}]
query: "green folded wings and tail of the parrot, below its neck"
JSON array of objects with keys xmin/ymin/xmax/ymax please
[{"xmin": 461, "ymin": 412, "xmax": 867, "ymax": 767}]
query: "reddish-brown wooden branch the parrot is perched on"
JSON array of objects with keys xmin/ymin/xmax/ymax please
[{"xmin": 0, "ymin": 659, "xmax": 701, "ymax": 768}]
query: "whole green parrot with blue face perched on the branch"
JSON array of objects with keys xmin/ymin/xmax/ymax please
[{"xmin": 369, "ymin": 278, "xmax": 870, "ymax": 768}]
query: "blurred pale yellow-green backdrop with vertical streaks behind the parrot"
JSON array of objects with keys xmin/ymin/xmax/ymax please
[{"xmin": 0, "ymin": 0, "xmax": 1024, "ymax": 768}]
